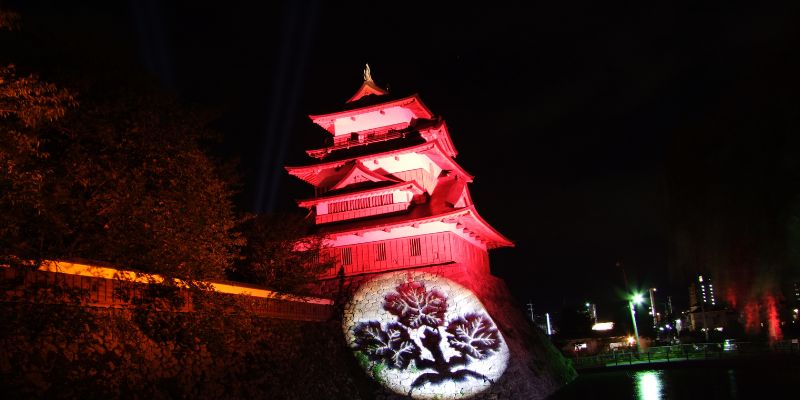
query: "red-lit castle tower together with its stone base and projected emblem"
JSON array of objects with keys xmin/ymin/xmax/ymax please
[{"xmin": 286, "ymin": 67, "xmax": 569, "ymax": 399}]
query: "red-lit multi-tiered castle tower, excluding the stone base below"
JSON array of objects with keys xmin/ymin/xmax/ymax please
[{"xmin": 286, "ymin": 66, "xmax": 513, "ymax": 284}]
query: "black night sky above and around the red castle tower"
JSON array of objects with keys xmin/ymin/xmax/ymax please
[{"xmin": 11, "ymin": 0, "xmax": 800, "ymax": 317}]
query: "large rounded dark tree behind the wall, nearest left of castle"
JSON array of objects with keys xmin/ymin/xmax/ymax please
[{"xmin": 57, "ymin": 94, "xmax": 243, "ymax": 279}]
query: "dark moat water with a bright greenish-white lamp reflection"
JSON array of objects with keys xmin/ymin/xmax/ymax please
[{"xmin": 549, "ymin": 360, "xmax": 800, "ymax": 400}]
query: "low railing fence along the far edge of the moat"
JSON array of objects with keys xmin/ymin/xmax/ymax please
[{"xmin": 572, "ymin": 339, "xmax": 800, "ymax": 369}]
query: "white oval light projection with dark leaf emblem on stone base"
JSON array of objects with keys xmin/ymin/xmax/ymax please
[{"xmin": 343, "ymin": 272, "xmax": 509, "ymax": 399}]
